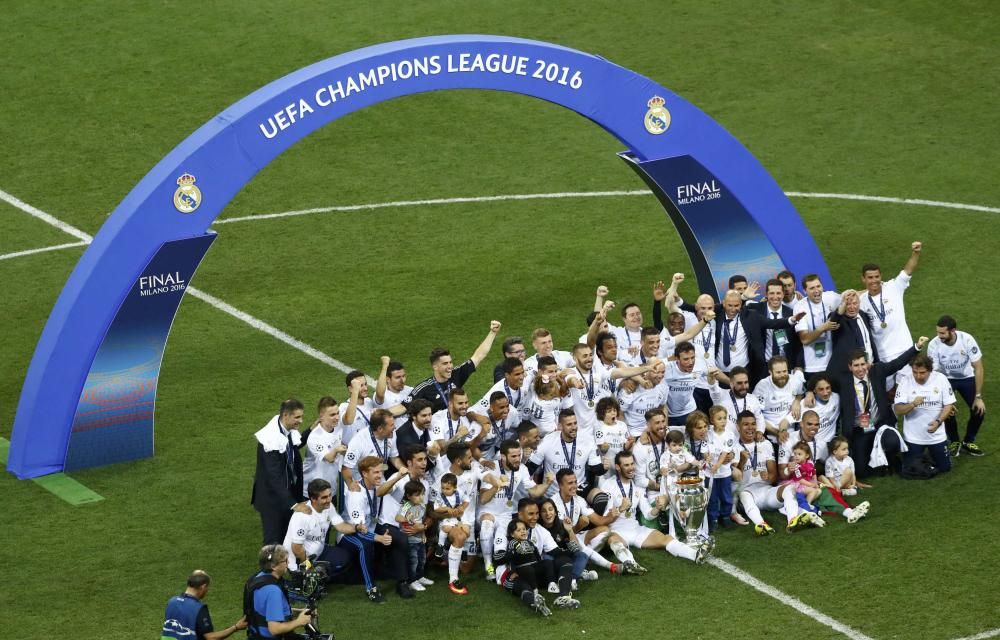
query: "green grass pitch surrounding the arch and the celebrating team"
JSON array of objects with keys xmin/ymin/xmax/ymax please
[{"xmin": 0, "ymin": 0, "xmax": 1000, "ymax": 640}]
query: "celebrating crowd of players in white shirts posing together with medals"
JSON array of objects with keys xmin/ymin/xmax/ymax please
[{"xmin": 272, "ymin": 243, "xmax": 985, "ymax": 613}]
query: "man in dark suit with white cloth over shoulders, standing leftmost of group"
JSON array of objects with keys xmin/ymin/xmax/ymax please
[{"xmin": 250, "ymin": 399, "xmax": 306, "ymax": 545}]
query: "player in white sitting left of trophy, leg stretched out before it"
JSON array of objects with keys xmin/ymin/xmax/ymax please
[{"xmin": 601, "ymin": 451, "xmax": 711, "ymax": 564}]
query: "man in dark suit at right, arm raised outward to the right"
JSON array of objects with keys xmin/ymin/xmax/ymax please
[{"xmin": 836, "ymin": 337, "xmax": 928, "ymax": 478}]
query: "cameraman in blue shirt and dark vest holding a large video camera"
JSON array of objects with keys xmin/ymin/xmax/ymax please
[{"xmin": 243, "ymin": 544, "xmax": 312, "ymax": 639}]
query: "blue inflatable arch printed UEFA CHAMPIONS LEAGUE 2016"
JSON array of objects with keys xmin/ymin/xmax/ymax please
[{"xmin": 8, "ymin": 35, "xmax": 832, "ymax": 478}]
